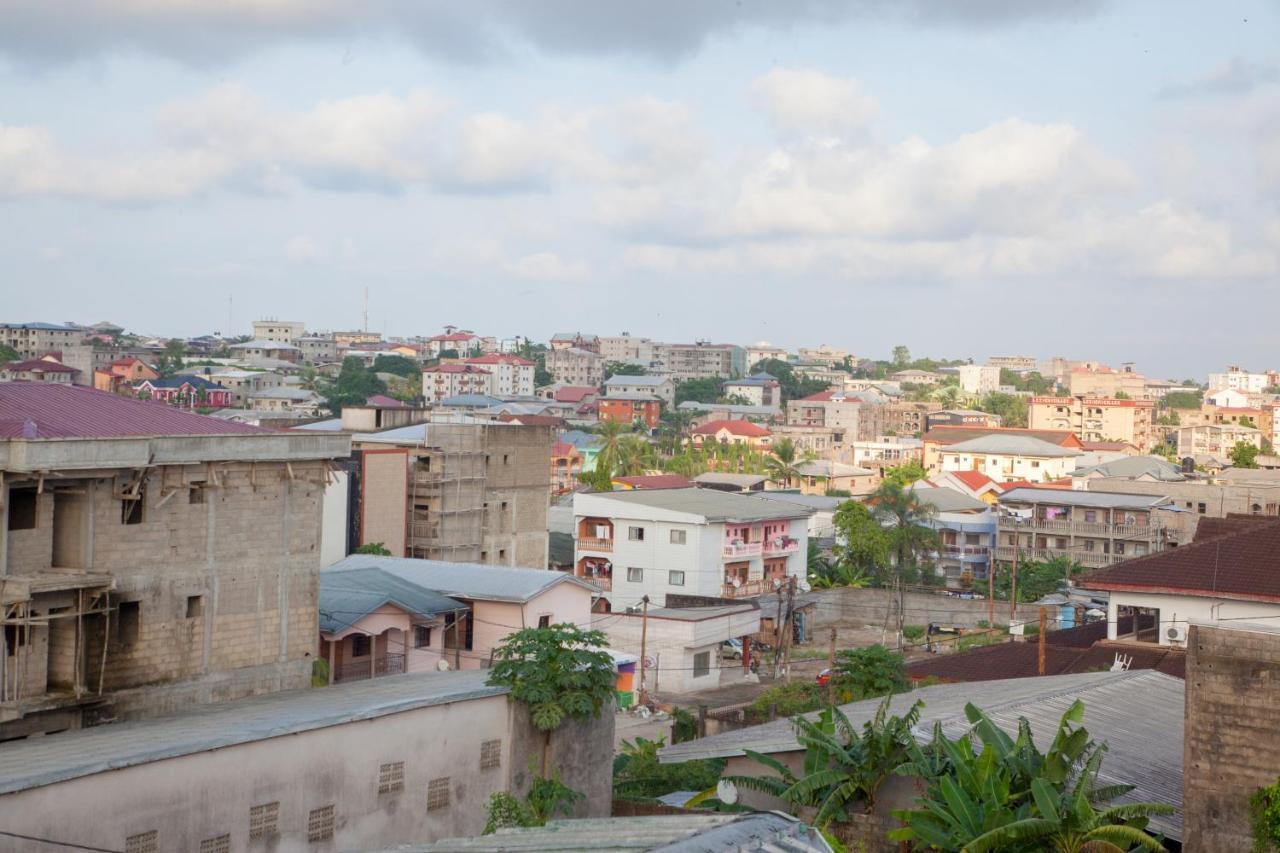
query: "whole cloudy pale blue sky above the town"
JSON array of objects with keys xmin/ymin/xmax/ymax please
[{"xmin": 0, "ymin": 0, "xmax": 1280, "ymax": 379}]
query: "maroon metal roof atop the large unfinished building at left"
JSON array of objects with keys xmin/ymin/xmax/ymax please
[{"xmin": 0, "ymin": 382, "xmax": 274, "ymax": 438}]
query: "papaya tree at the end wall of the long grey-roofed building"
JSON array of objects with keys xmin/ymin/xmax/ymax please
[{"xmin": 486, "ymin": 622, "xmax": 616, "ymax": 779}]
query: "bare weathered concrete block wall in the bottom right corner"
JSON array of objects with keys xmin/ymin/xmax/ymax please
[{"xmin": 1183, "ymin": 625, "xmax": 1280, "ymax": 850}]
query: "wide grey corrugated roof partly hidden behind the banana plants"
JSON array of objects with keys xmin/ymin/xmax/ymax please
[{"xmin": 658, "ymin": 670, "xmax": 1185, "ymax": 839}]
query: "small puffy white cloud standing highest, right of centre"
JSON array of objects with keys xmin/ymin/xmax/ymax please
[{"xmin": 751, "ymin": 68, "xmax": 879, "ymax": 136}]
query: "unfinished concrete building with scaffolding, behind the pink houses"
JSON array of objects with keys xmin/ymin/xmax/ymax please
[{"xmin": 352, "ymin": 420, "xmax": 554, "ymax": 569}]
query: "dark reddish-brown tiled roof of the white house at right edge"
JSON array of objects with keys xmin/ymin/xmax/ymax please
[{"xmin": 1076, "ymin": 519, "xmax": 1280, "ymax": 602}]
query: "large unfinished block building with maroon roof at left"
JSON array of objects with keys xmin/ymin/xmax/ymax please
[{"xmin": 0, "ymin": 382, "xmax": 349, "ymax": 740}]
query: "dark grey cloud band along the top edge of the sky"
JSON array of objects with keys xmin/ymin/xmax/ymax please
[{"xmin": 0, "ymin": 0, "xmax": 1107, "ymax": 64}]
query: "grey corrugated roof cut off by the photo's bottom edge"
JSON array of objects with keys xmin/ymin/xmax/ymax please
[{"xmin": 392, "ymin": 812, "xmax": 831, "ymax": 853}]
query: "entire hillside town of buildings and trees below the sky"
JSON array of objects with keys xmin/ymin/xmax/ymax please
[{"xmin": 0, "ymin": 319, "xmax": 1280, "ymax": 850}]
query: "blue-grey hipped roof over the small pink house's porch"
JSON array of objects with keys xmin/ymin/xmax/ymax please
[{"xmin": 320, "ymin": 566, "xmax": 467, "ymax": 634}]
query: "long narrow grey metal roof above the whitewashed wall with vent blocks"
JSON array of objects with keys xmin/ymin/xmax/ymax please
[{"xmin": 0, "ymin": 670, "xmax": 507, "ymax": 794}]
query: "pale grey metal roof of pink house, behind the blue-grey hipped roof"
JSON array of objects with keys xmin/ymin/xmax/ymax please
[{"xmin": 320, "ymin": 553, "xmax": 595, "ymax": 603}]
